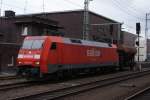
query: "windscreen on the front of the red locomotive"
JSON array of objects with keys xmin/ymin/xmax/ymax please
[{"xmin": 22, "ymin": 40, "xmax": 44, "ymax": 49}]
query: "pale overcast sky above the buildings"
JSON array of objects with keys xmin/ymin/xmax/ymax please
[{"xmin": 0, "ymin": 0, "xmax": 150, "ymax": 34}]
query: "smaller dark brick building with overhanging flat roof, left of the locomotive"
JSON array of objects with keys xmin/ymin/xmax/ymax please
[{"xmin": 0, "ymin": 11, "xmax": 60, "ymax": 71}]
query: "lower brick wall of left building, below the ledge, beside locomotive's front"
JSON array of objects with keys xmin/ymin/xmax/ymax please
[{"xmin": 0, "ymin": 43, "xmax": 20, "ymax": 72}]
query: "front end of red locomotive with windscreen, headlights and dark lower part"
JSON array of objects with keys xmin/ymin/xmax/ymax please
[{"xmin": 17, "ymin": 36, "xmax": 45, "ymax": 76}]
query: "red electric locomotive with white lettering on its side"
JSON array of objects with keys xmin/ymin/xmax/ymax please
[{"xmin": 17, "ymin": 36, "xmax": 135, "ymax": 77}]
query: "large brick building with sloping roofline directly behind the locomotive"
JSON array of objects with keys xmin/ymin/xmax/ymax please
[{"xmin": 34, "ymin": 10, "xmax": 121, "ymax": 43}]
